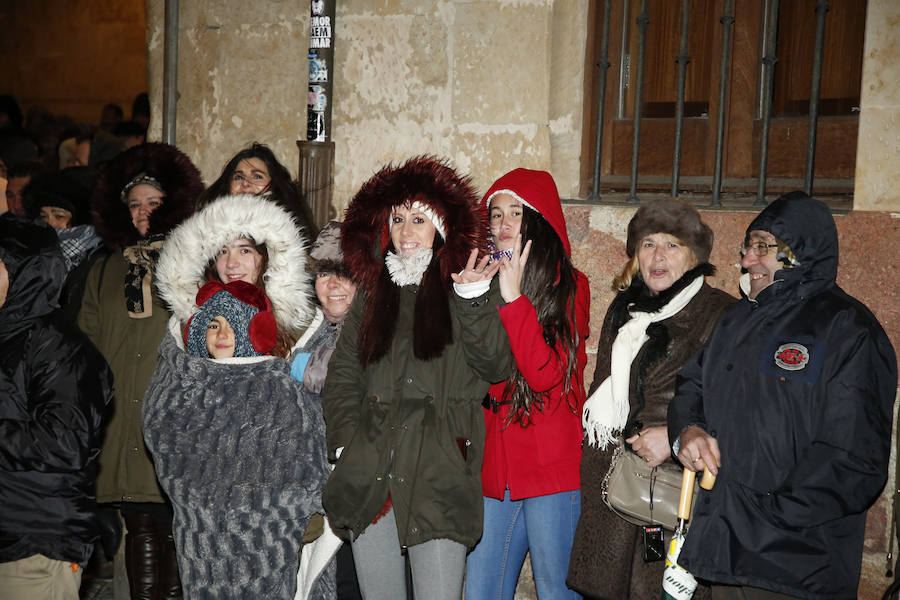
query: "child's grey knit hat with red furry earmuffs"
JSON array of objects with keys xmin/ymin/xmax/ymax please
[{"xmin": 184, "ymin": 281, "xmax": 278, "ymax": 358}]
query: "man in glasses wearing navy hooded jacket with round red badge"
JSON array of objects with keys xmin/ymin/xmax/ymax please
[{"xmin": 668, "ymin": 192, "xmax": 897, "ymax": 599}]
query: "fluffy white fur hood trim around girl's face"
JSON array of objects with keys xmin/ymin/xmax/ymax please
[{"xmin": 155, "ymin": 194, "xmax": 315, "ymax": 335}]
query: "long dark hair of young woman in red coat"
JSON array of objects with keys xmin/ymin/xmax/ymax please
[{"xmin": 504, "ymin": 206, "xmax": 580, "ymax": 427}]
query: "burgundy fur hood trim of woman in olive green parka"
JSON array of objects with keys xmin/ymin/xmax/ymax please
[{"xmin": 341, "ymin": 156, "xmax": 490, "ymax": 292}]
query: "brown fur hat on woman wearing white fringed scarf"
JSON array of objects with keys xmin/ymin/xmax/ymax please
[{"xmin": 625, "ymin": 198, "xmax": 713, "ymax": 263}]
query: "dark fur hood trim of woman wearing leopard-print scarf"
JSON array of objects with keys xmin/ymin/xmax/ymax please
[{"xmin": 91, "ymin": 143, "xmax": 203, "ymax": 249}]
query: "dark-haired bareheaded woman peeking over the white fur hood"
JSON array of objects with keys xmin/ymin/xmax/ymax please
[{"xmin": 198, "ymin": 142, "xmax": 316, "ymax": 237}]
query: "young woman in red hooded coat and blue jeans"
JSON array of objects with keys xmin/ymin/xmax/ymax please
[{"xmin": 466, "ymin": 169, "xmax": 590, "ymax": 600}]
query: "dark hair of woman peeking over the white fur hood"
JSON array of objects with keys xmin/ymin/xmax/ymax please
[{"xmin": 197, "ymin": 142, "xmax": 318, "ymax": 239}]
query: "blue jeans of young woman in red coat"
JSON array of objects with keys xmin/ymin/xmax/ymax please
[{"xmin": 466, "ymin": 490, "xmax": 581, "ymax": 600}]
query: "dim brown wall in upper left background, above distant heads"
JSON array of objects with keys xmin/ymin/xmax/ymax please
[{"xmin": 0, "ymin": 0, "xmax": 147, "ymax": 124}]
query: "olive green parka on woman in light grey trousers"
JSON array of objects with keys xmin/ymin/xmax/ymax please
[{"xmin": 323, "ymin": 286, "xmax": 509, "ymax": 548}]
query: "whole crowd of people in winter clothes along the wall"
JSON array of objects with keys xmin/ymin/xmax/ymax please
[{"xmin": 0, "ymin": 89, "xmax": 897, "ymax": 600}]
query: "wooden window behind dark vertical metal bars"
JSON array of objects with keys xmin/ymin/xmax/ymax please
[{"xmin": 582, "ymin": 0, "xmax": 866, "ymax": 208}]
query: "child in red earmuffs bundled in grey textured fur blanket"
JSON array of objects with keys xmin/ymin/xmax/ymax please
[{"xmin": 144, "ymin": 278, "xmax": 334, "ymax": 599}]
